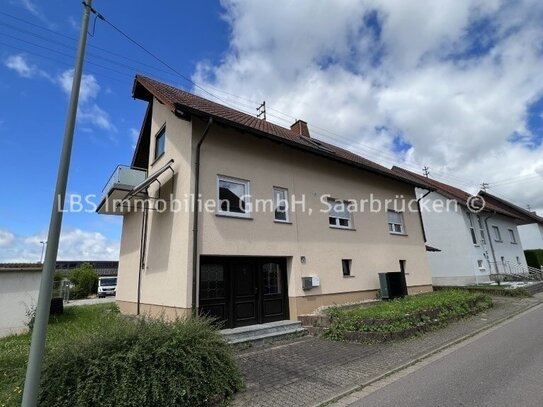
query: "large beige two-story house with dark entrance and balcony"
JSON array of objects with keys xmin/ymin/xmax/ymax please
[{"xmin": 98, "ymin": 76, "xmax": 432, "ymax": 327}]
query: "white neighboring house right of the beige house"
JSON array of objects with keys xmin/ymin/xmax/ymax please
[{"xmin": 393, "ymin": 167, "xmax": 533, "ymax": 286}]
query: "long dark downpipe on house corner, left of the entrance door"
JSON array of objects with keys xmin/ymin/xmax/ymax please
[{"xmin": 192, "ymin": 116, "xmax": 213, "ymax": 314}]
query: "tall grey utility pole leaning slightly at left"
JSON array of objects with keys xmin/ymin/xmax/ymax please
[{"xmin": 21, "ymin": 0, "xmax": 92, "ymax": 407}]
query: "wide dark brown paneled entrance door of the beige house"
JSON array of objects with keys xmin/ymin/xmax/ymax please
[{"xmin": 200, "ymin": 256, "xmax": 288, "ymax": 328}]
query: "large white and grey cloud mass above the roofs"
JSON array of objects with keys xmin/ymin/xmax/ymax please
[{"xmin": 193, "ymin": 0, "xmax": 543, "ymax": 215}]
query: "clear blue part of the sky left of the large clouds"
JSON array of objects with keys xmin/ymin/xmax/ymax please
[{"xmin": 0, "ymin": 0, "xmax": 228, "ymax": 261}]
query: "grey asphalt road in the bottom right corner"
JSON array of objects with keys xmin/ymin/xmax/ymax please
[{"xmin": 351, "ymin": 307, "xmax": 543, "ymax": 407}]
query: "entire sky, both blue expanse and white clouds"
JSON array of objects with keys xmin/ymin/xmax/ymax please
[{"xmin": 0, "ymin": 0, "xmax": 543, "ymax": 261}]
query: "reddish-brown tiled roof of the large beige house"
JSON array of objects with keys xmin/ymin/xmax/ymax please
[{"xmin": 132, "ymin": 75, "xmax": 434, "ymax": 190}]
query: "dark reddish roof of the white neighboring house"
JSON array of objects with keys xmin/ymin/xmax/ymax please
[{"xmin": 392, "ymin": 167, "xmax": 524, "ymax": 221}]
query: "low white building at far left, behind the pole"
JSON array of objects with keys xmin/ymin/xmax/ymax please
[{"xmin": 0, "ymin": 264, "xmax": 42, "ymax": 337}]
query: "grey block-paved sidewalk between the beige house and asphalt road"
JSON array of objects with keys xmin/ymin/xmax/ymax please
[{"xmin": 233, "ymin": 295, "xmax": 543, "ymax": 407}]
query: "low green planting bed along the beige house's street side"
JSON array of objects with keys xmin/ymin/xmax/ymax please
[{"xmin": 324, "ymin": 290, "xmax": 492, "ymax": 342}]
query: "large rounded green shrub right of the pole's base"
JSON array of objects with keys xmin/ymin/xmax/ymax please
[{"xmin": 40, "ymin": 317, "xmax": 242, "ymax": 407}]
